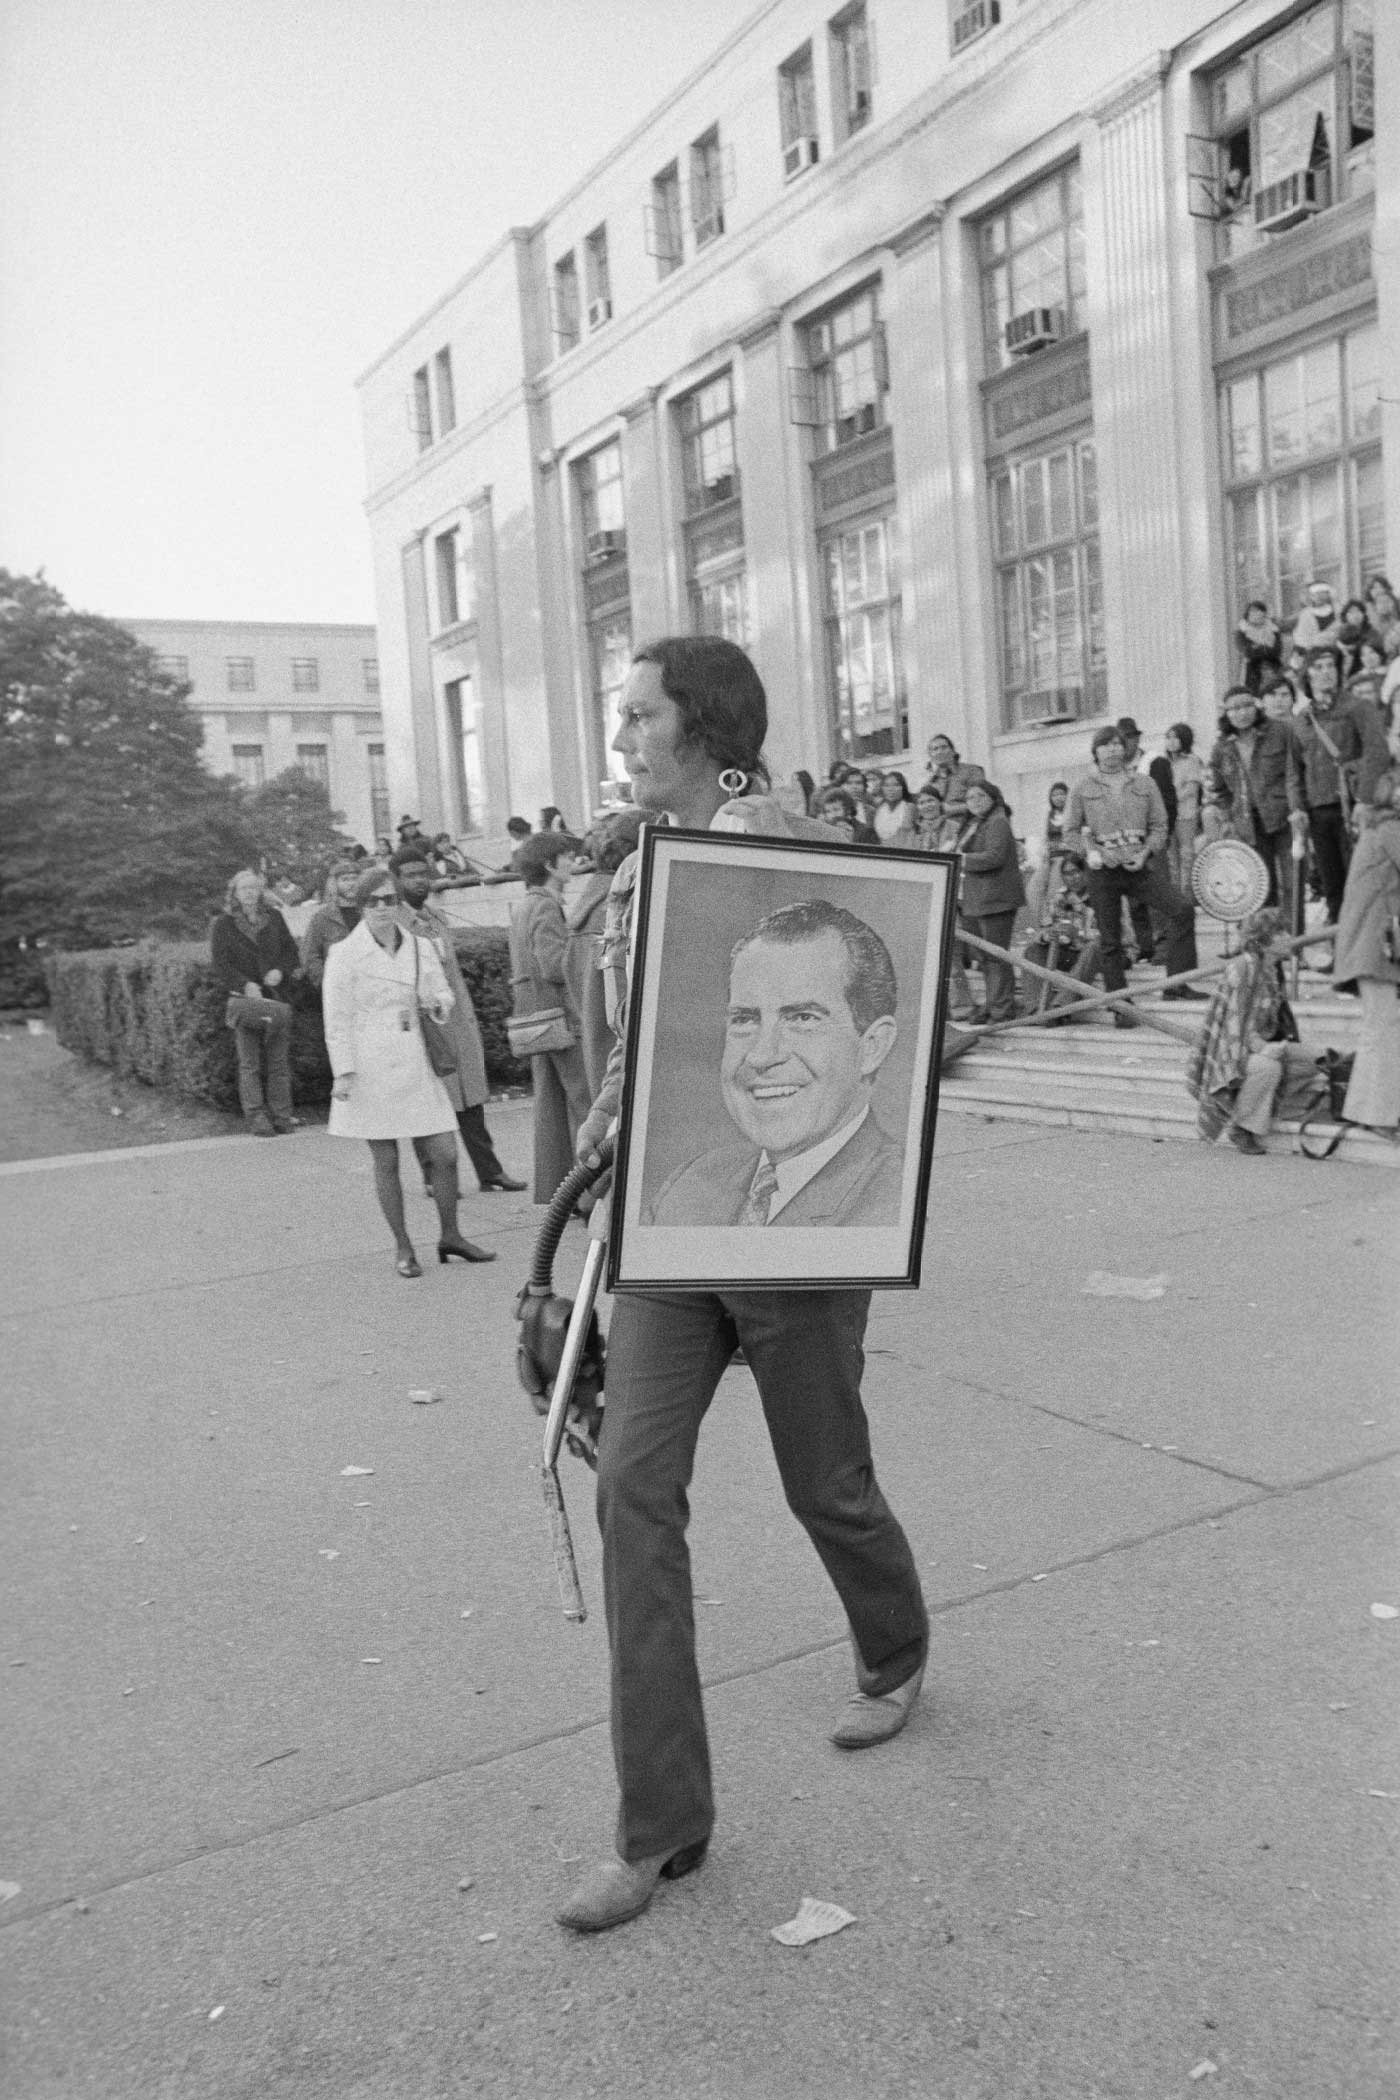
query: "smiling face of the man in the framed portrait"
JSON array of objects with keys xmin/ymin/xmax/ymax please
[{"xmin": 720, "ymin": 932, "xmax": 894, "ymax": 1159}]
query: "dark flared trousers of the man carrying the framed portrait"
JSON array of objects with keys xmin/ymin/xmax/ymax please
[{"xmin": 598, "ymin": 1292, "xmax": 928, "ymax": 1861}]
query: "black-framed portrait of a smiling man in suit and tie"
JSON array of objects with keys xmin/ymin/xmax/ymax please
[{"xmin": 607, "ymin": 825, "xmax": 957, "ymax": 1292}]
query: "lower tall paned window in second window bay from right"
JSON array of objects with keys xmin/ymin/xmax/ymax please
[{"xmin": 991, "ymin": 437, "xmax": 1108, "ymax": 729}]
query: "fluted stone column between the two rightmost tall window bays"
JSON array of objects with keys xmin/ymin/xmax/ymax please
[{"xmin": 1083, "ymin": 57, "xmax": 1194, "ymax": 733}]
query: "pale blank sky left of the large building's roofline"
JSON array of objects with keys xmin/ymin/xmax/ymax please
[{"xmin": 0, "ymin": 0, "xmax": 760, "ymax": 620}]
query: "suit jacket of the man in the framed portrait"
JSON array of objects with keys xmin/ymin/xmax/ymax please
[{"xmin": 642, "ymin": 1115, "xmax": 905, "ymax": 1226}]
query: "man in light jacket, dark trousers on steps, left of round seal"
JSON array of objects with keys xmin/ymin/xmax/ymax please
[{"xmin": 1064, "ymin": 722, "xmax": 1205, "ymax": 1029}]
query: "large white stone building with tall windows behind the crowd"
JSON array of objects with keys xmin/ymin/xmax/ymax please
[{"xmin": 361, "ymin": 0, "xmax": 1400, "ymax": 836}]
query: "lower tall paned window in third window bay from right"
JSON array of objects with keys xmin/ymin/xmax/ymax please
[{"xmin": 823, "ymin": 517, "xmax": 909, "ymax": 758}]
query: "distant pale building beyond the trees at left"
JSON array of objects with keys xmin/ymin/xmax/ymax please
[{"xmin": 122, "ymin": 620, "xmax": 388, "ymax": 846}]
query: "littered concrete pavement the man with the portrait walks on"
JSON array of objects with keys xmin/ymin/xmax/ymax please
[{"xmin": 0, "ymin": 1107, "xmax": 1400, "ymax": 2100}]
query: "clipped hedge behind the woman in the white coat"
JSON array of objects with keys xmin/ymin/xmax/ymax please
[{"xmin": 48, "ymin": 926, "xmax": 529, "ymax": 1109}]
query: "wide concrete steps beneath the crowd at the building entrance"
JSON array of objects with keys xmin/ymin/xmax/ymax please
[{"xmin": 938, "ymin": 970, "xmax": 1400, "ymax": 1170}]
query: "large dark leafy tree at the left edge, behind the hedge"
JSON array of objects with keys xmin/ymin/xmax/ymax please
[{"xmin": 0, "ymin": 569, "xmax": 258, "ymax": 947}]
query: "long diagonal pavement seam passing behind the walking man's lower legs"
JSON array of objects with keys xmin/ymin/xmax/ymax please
[{"xmin": 0, "ymin": 1449, "xmax": 1400, "ymax": 1932}]
